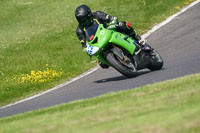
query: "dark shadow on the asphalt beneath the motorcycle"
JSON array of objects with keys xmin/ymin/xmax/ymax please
[{"xmin": 94, "ymin": 70, "xmax": 151, "ymax": 83}]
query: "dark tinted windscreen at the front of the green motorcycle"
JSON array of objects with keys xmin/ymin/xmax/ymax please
[{"xmin": 86, "ymin": 25, "xmax": 99, "ymax": 41}]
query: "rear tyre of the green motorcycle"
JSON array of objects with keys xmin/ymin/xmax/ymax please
[{"xmin": 148, "ymin": 49, "xmax": 163, "ymax": 71}]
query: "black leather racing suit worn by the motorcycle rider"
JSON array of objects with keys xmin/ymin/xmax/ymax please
[{"xmin": 76, "ymin": 11, "xmax": 140, "ymax": 48}]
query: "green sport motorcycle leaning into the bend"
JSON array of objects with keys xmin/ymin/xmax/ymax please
[{"xmin": 86, "ymin": 24, "xmax": 163, "ymax": 78}]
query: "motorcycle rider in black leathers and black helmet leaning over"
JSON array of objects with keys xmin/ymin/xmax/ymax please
[{"xmin": 75, "ymin": 5, "xmax": 146, "ymax": 68}]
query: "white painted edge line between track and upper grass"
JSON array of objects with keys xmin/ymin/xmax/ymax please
[{"xmin": 0, "ymin": 0, "xmax": 200, "ymax": 110}]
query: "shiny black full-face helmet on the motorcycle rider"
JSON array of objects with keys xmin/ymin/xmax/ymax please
[{"xmin": 75, "ymin": 5, "xmax": 92, "ymax": 27}]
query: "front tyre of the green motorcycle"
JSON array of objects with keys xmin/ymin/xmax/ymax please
[{"xmin": 106, "ymin": 52, "xmax": 137, "ymax": 78}]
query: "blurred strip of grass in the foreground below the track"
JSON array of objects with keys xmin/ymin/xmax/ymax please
[{"xmin": 0, "ymin": 74, "xmax": 200, "ymax": 133}]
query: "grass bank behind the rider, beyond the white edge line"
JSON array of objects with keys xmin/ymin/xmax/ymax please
[{"xmin": 0, "ymin": 0, "xmax": 194, "ymax": 106}]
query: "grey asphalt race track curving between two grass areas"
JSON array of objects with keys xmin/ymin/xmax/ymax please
[{"xmin": 0, "ymin": 3, "xmax": 200, "ymax": 117}]
